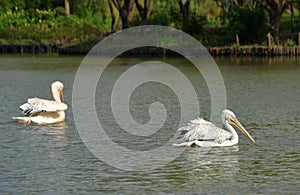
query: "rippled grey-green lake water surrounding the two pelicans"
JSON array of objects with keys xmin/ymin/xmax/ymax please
[{"xmin": 0, "ymin": 56, "xmax": 300, "ymax": 194}]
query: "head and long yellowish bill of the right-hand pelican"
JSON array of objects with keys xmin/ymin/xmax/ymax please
[{"xmin": 222, "ymin": 109, "xmax": 255, "ymax": 143}]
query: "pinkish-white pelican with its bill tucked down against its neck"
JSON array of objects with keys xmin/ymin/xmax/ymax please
[{"xmin": 13, "ymin": 81, "xmax": 68, "ymax": 125}]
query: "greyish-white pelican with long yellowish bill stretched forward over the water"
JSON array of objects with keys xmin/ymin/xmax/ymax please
[{"xmin": 173, "ymin": 109, "xmax": 255, "ymax": 147}]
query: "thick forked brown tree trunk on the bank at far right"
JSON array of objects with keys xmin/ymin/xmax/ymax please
[{"xmin": 258, "ymin": 0, "xmax": 287, "ymax": 44}]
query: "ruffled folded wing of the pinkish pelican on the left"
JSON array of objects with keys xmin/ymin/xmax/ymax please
[{"xmin": 20, "ymin": 98, "xmax": 68, "ymax": 116}]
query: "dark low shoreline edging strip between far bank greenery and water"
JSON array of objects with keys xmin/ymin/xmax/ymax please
[{"xmin": 0, "ymin": 44, "xmax": 300, "ymax": 57}]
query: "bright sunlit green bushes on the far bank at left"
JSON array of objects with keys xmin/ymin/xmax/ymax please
[{"xmin": 0, "ymin": 10, "xmax": 100, "ymax": 44}]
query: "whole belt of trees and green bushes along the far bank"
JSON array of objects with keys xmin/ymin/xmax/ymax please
[{"xmin": 0, "ymin": 0, "xmax": 300, "ymax": 47}]
